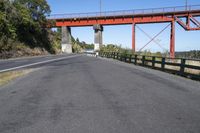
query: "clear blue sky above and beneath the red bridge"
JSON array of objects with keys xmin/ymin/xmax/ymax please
[{"xmin": 47, "ymin": 0, "xmax": 200, "ymax": 52}]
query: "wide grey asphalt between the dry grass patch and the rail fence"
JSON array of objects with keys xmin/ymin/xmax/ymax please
[{"xmin": 0, "ymin": 55, "xmax": 200, "ymax": 133}]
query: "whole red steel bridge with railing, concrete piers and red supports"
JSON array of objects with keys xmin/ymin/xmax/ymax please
[{"xmin": 48, "ymin": 5, "xmax": 200, "ymax": 58}]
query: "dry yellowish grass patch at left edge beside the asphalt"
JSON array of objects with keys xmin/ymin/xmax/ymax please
[{"xmin": 0, "ymin": 69, "xmax": 32, "ymax": 86}]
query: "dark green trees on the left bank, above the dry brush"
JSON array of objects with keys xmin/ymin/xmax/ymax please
[{"xmin": 0, "ymin": 0, "xmax": 53, "ymax": 52}]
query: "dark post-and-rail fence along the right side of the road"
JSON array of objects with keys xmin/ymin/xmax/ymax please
[{"xmin": 99, "ymin": 52, "xmax": 200, "ymax": 81}]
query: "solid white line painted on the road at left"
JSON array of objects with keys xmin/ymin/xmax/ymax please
[{"xmin": 0, "ymin": 55, "xmax": 80, "ymax": 73}]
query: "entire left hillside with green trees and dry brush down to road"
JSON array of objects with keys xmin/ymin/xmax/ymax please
[{"xmin": 0, "ymin": 0, "xmax": 60, "ymax": 58}]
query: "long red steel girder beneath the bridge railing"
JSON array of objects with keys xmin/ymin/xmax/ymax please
[{"xmin": 52, "ymin": 10, "xmax": 200, "ymax": 27}]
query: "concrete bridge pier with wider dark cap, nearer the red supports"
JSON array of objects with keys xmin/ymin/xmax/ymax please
[{"xmin": 93, "ymin": 24, "xmax": 103, "ymax": 51}]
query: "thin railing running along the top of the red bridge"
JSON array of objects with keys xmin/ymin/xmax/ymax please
[{"xmin": 47, "ymin": 5, "xmax": 200, "ymax": 19}]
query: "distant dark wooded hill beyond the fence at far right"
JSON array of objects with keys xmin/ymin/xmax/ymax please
[{"xmin": 175, "ymin": 50, "xmax": 200, "ymax": 59}]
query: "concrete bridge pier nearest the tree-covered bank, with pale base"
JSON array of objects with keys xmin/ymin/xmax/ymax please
[{"xmin": 61, "ymin": 26, "xmax": 72, "ymax": 54}]
